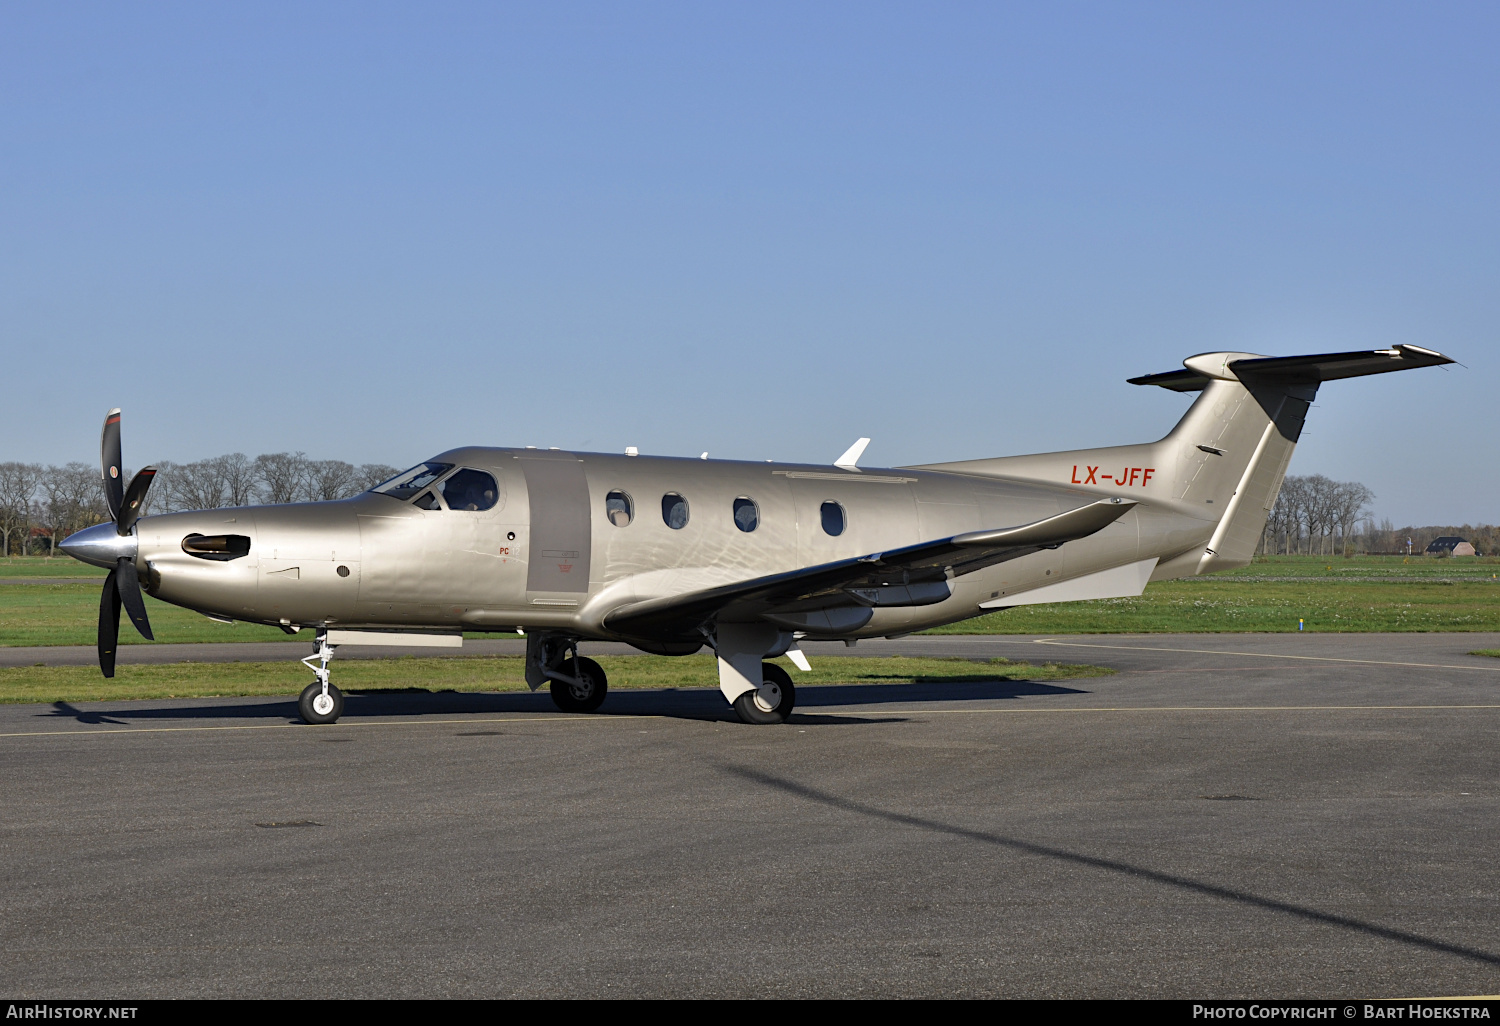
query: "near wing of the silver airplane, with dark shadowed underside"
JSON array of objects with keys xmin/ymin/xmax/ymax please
[{"xmin": 605, "ymin": 498, "xmax": 1136, "ymax": 638}]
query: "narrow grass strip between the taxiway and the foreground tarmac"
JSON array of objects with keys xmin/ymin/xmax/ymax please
[{"xmin": 0, "ymin": 656, "xmax": 1115, "ymax": 702}]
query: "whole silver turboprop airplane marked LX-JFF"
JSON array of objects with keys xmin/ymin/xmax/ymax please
[{"xmin": 62, "ymin": 345, "xmax": 1454, "ymax": 725}]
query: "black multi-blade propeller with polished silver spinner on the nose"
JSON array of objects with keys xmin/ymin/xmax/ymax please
[{"xmin": 59, "ymin": 410, "xmax": 156, "ymax": 677}]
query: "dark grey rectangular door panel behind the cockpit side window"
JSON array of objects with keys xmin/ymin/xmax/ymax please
[{"xmin": 518, "ymin": 452, "xmax": 593, "ymax": 597}]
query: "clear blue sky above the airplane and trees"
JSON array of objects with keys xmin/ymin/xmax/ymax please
[{"xmin": 0, "ymin": 3, "xmax": 1500, "ymax": 522}]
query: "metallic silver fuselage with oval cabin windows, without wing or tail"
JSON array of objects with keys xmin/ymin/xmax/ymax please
[{"xmin": 70, "ymin": 447, "xmax": 1215, "ymax": 641}]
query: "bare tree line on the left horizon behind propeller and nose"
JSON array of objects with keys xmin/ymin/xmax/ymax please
[{"xmin": 0, "ymin": 453, "xmax": 399, "ymax": 555}]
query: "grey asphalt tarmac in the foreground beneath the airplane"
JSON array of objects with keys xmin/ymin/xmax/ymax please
[{"xmin": 0, "ymin": 635, "xmax": 1500, "ymax": 999}]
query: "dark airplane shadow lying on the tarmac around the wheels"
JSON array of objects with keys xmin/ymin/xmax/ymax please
[{"xmin": 39, "ymin": 680, "xmax": 1088, "ymax": 726}]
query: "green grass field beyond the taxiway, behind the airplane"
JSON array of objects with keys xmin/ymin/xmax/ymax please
[{"xmin": 0, "ymin": 557, "xmax": 1500, "ymax": 647}]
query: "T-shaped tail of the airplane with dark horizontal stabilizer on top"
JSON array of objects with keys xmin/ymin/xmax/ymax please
[{"xmin": 921, "ymin": 345, "xmax": 1454, "ymax": 581}]
